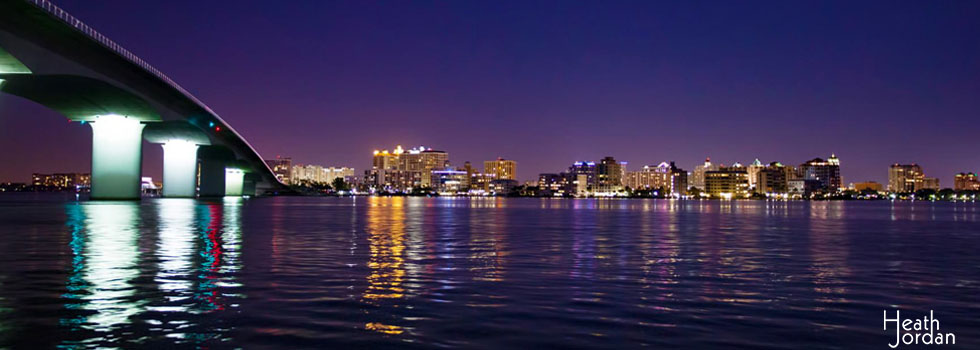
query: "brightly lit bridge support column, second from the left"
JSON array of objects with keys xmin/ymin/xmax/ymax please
[{"xmin": 163, "ymin": 140, "xmax": 197, "ymax": 198}]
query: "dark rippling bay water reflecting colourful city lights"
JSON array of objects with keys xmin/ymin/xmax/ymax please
[{"xmin": 0, "ymin": 194, "xmax": 980, "ymax": 349}]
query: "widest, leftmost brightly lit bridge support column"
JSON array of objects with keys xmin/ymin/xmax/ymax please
[{"xmin": 90, "ymin": 115, "xmax": 144, "ymax": 199}]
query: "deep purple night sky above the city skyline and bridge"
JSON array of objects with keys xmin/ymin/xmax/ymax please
[{"xmin": 0, "ymin": 0, "xmax": 980, "ymax": 187}]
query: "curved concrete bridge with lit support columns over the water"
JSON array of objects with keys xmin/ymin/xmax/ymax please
[{"xmin": 0, "ymin": 0, "xmax": 285, "ymax": 199}]
